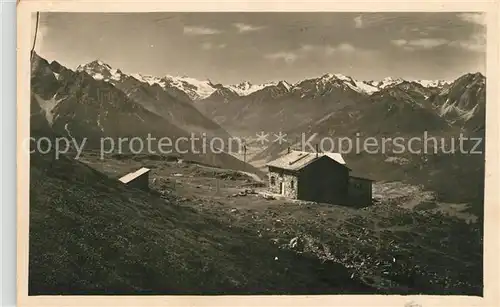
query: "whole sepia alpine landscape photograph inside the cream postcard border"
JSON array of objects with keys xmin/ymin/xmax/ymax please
[{"xmin": 19, "ymin": 4, "xmax": 489, "ymax": 304}]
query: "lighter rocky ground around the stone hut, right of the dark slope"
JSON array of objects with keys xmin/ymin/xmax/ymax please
[{"xmin": 82, "ymin": 155, "xmax": 482, "ymax": 295}]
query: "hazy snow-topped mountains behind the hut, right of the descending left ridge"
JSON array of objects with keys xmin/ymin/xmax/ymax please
[{"xmin": 196, "ymin": 73, "xmax": 485, "ymax": 135}]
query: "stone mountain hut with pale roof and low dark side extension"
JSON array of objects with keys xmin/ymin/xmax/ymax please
[{"xmin": 267, "ymin": 151, "xmax": 372, "ymax": 205}]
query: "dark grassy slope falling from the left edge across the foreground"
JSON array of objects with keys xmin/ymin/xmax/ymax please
[{"xmin": 29, "ymin": 155, "xmax": 374, "ymax": 295}]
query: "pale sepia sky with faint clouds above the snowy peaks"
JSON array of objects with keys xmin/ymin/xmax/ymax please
[{"xmin": 32, "ymin": 12, "xmax": 486, "ymax": 84}]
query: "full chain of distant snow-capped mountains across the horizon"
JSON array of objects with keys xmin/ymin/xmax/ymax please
[{"xmin": 67, "ymin": 60, "xmax": 485, "ymax": 136}]
